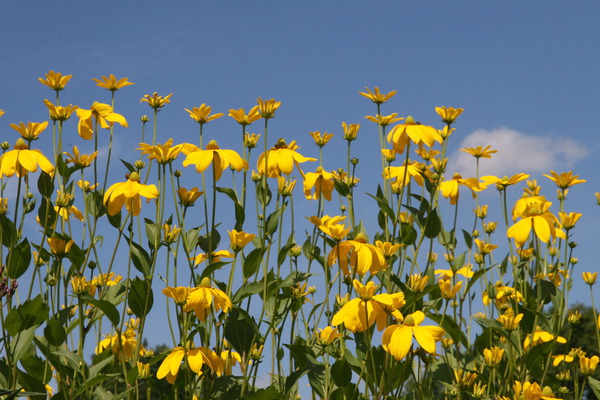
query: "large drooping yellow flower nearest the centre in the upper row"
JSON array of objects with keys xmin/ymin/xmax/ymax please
[{"xmin": 256, "ymin": 139, "xmax": 317, "ymax": 178}]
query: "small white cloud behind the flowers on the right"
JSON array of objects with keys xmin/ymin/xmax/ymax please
[{"xmin": 447, "ymin": 127, "xmax": 588, "ymax": 176}]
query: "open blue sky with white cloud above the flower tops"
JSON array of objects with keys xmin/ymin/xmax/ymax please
[{"xmin": 0, "ymin": 0, "xmax": 600, "ymax": 360}]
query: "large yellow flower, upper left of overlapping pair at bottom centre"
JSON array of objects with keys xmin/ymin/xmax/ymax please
[{"xmin": 331, "ymin": 279, "xmax": 404, "ymax": 332}]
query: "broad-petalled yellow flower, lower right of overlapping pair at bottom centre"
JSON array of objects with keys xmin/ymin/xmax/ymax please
[{"xmin": 381, "ymin": 311, "xmax": 445, "ymax": 361}]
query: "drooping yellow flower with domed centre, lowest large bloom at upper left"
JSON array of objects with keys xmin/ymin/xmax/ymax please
[{"xmin": 104, "ymin": 172, "xmax": 158, "ymax": 216}]
